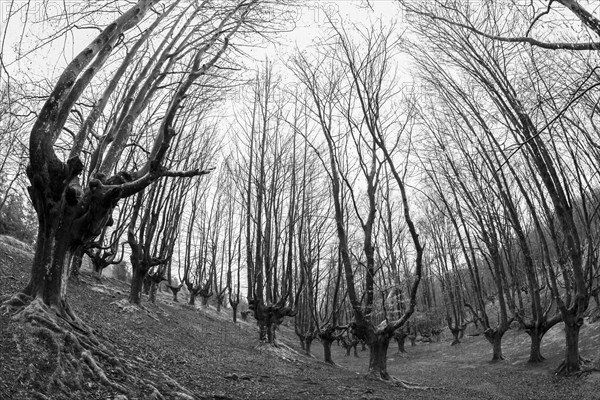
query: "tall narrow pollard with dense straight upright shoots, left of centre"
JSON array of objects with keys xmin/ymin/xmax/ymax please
[{"xmin": 238, "ymin": 60, "xmax": 302, "ymax": 343}]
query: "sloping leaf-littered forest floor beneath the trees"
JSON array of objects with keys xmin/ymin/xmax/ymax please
[{"xmin": 0, "ymin": 238, "xmax": 600, "ymax": 400}]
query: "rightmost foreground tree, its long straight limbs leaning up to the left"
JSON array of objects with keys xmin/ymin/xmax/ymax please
[{"xmin": 408, "ymin": 2, "xmax": 596, "ymax": 373}]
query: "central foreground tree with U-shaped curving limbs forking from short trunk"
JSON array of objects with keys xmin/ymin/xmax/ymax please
[{"xmin": 294, "ymin": 21, "xmax": 423, "ymax": 379}]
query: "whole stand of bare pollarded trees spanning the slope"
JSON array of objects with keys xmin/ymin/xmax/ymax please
[{"xmin": 0, "ymin": 0, "xmax": 600, "ymax": 390}]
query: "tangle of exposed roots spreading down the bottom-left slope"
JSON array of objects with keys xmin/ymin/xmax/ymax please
[{"xmin": 0, "ymin": 293, "xmax": 191, "ymax": 400}]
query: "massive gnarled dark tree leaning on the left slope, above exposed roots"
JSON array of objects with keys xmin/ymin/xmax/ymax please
[{"xmin": 2, "ymin": 0, "xmax": 257, "ymax": 319}]
